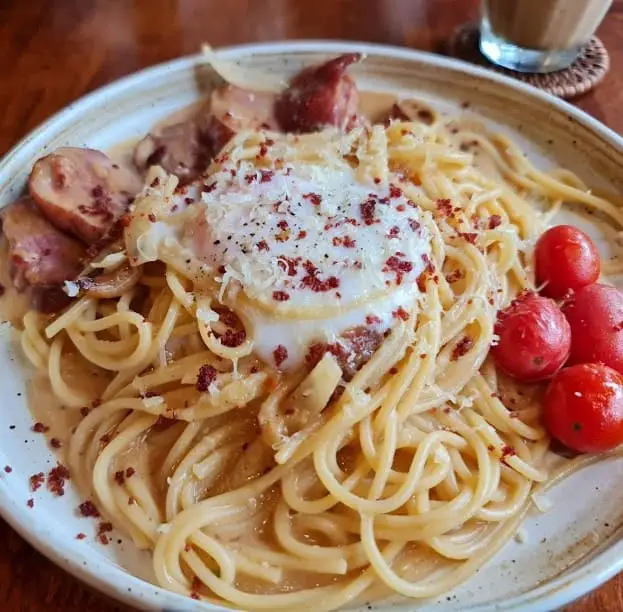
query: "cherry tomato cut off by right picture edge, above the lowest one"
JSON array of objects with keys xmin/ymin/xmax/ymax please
[{"xmin": 562, "ymin": 284, "xmax": 623, "ymax": 373}]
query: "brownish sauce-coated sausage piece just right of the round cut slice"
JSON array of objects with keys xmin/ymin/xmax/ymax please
[{"xmin": 134, "ymin": 120, "xmax": 212, "ymax": 184}]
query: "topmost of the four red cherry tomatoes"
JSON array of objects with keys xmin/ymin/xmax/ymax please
[{"xmin": 534, "ymin": 225, "xmax": 601, "ymax": 299}]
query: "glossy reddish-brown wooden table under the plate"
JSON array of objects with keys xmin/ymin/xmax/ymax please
[{"xmin": 0, "ymin": 0, "xmax": 623, "ymax": 612}]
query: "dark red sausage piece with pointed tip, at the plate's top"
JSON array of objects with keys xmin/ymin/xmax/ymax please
[{"xmin": 275, "ymin": 53, "xmax": 362, "ymax": 132}]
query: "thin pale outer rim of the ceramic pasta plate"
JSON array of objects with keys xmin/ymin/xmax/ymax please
[{"xmin": 0, "ymin": 40, "xmax": 623, "ymax": 612}]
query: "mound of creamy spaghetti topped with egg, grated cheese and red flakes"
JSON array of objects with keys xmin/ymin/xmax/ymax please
[{"xmin": 17, "ymin": 101, "xmax": 623, "ymax": 610}]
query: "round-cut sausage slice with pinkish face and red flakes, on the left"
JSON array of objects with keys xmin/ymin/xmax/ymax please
[{"xmin": 28, "ymin": 147, "xmax": 142, "ymax": 243}]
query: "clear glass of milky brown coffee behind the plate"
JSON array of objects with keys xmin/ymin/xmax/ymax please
[{"xmin": 480, "ymin": 0, "xmax": 612, "ymax": 72}]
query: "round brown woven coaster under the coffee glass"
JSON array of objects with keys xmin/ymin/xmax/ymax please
[{"xmin": 448, "ymin": 23, "xmax": 610, "ymax": 98}]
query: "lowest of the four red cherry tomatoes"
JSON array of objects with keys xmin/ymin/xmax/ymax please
[{"xmin": 544, "ymin": 363, "xmax": 623, "ymax": 453}]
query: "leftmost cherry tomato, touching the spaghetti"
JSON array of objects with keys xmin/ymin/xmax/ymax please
[{"xmin": 491, "ymin": 293, "xmax": 571, "ymax": 382}]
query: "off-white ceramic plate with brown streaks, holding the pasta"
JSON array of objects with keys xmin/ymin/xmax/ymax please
[{"xmin": 0, "ymin": 42, "xmax": 623, "ymax": 612}]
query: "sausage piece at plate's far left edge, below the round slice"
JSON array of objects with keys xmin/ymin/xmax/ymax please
[{"xmin": 1, "ymin": 196, "xmax": 86, "ymax": 290}]
